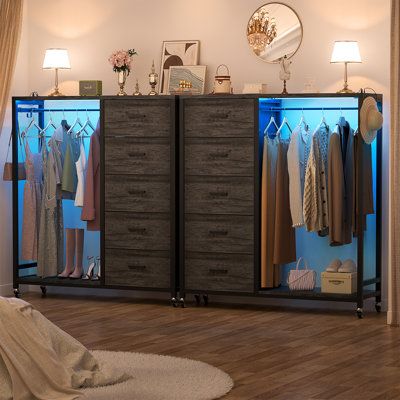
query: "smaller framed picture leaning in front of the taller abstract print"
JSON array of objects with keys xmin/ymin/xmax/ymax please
[{"xmin": 167, "ymin": 65, "xmax": 207, "ymax": 94}]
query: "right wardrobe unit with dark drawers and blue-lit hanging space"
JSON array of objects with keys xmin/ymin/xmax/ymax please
[{"xmin": 179, "ymin": 93, "xmax": 382, "ymax": 317}]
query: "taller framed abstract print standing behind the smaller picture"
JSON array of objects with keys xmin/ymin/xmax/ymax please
[{"xmin": 159, "ymin": 40, "xmax": 200, "ymax": 94}]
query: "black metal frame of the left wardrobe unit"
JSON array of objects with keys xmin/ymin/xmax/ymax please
[{"xmin": 12, "ymin": 96, "xmax": 179, "ymax": 298}]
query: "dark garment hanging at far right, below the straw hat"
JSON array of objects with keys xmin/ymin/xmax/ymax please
[{"xmin": 352, "ymin": 130, "xmax": 374, "ymax": 236}]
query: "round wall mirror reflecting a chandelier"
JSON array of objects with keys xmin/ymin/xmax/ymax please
[{"xmin": 247, "ymin": 3, "xmax": 303, "ymax": 63}]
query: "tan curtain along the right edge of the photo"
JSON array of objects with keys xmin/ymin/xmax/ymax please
[{"xmin": 388, "ymin": 0, "xmax": 400, "ymax": 326}]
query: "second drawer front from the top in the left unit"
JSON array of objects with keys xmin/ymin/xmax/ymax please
[{"xmin": 105, "ymin": 138, "xmax": 171, "ymax": 175}]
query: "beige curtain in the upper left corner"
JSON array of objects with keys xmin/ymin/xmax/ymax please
[{"xmin": 0, "ymin": 0, "xmax": 23, "ymax": 132}]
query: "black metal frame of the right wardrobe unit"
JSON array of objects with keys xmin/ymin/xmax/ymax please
[{"xmin": 179, "ymin": 92, "xmax": 382, "ymax": 317}]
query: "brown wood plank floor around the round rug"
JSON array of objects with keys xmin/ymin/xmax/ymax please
[{"xmin": 23, "ymin": 294, "xmax": 400, "ymax": 400}]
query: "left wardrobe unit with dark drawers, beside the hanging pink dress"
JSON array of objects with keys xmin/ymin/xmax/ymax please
[{"xmin": 12, "ymin": 96, "xmax": 177, "ymax": 298}]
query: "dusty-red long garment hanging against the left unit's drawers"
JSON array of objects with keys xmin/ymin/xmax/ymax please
[{"xmin": 81, "ymin": 121, "xmax": 100, "ymax": 231}]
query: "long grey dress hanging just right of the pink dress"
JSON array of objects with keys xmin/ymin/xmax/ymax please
[{"xmin": 37, "ymin": 140, "xmax": 64, "ymax": 277}]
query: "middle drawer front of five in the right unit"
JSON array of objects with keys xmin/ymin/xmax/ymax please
[{"xmin": 185, "ymin": 176, "xmax": 254, "ymax": 215}]
